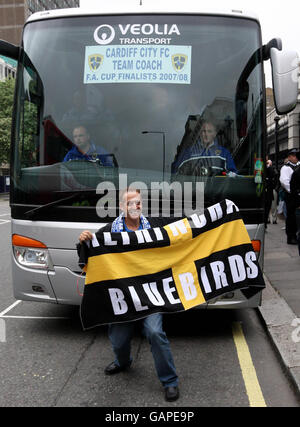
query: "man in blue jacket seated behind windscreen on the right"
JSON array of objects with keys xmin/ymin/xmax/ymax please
[{"xmin": 171, "ymin": 120, "xmax": 237, "ymax": 175}]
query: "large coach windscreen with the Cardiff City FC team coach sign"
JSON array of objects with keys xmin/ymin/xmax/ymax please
[{"xmin": 11, "ymin": 15, "xmax": 264, "ymax": 223}]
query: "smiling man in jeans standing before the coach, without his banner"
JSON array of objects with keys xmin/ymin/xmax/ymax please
[{"xmin": 79, "ymin": 189, "xmax": 179, "ymax": 401}]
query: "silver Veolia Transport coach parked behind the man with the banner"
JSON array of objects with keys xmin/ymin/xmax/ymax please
[{"xmin": 0, "ymin": 0, "xmax": 298, "ymax": 308}]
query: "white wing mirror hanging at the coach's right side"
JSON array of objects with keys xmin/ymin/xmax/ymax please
[{"xmin": 270, "ymin": 48, "xmax": 299, "ymax": 114}]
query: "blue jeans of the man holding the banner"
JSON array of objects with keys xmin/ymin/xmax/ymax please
[{"xmin": 108, "ymin": 314, "xmax": 178, "ymax": 387}]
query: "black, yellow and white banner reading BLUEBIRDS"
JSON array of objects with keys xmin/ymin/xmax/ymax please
[{"xmin": 81, "ymin": 200, "xmax": 264, "ymax": 329}]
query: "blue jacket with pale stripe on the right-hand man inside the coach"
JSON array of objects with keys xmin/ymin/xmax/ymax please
[{"xmin": 172, "ymin": 139, "xmax": 237, "ymax": 173}]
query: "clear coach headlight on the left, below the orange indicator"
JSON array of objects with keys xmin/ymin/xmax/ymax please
[{"xmin": 13, "ymin": 246, "xmax": 52, "ymax": 270}]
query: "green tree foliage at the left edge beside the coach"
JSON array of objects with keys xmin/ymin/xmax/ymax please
[{"xmin": 0, "ymin": 79, "xmax": 15, "ymax": 165}]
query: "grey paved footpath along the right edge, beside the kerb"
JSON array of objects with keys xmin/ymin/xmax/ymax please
[{"xmin": 259, "ymin": 219, "xmax": 300, "ymax": 397}]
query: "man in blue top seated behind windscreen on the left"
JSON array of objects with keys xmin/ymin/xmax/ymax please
[{"xmin": 63, "ymin": 125, "xmax": 114, "ymax": 166}]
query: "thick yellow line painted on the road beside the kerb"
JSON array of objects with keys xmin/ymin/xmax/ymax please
[{"xmin": 232, "ymin": 322, "xmax": 267, "ymax": 407}]
